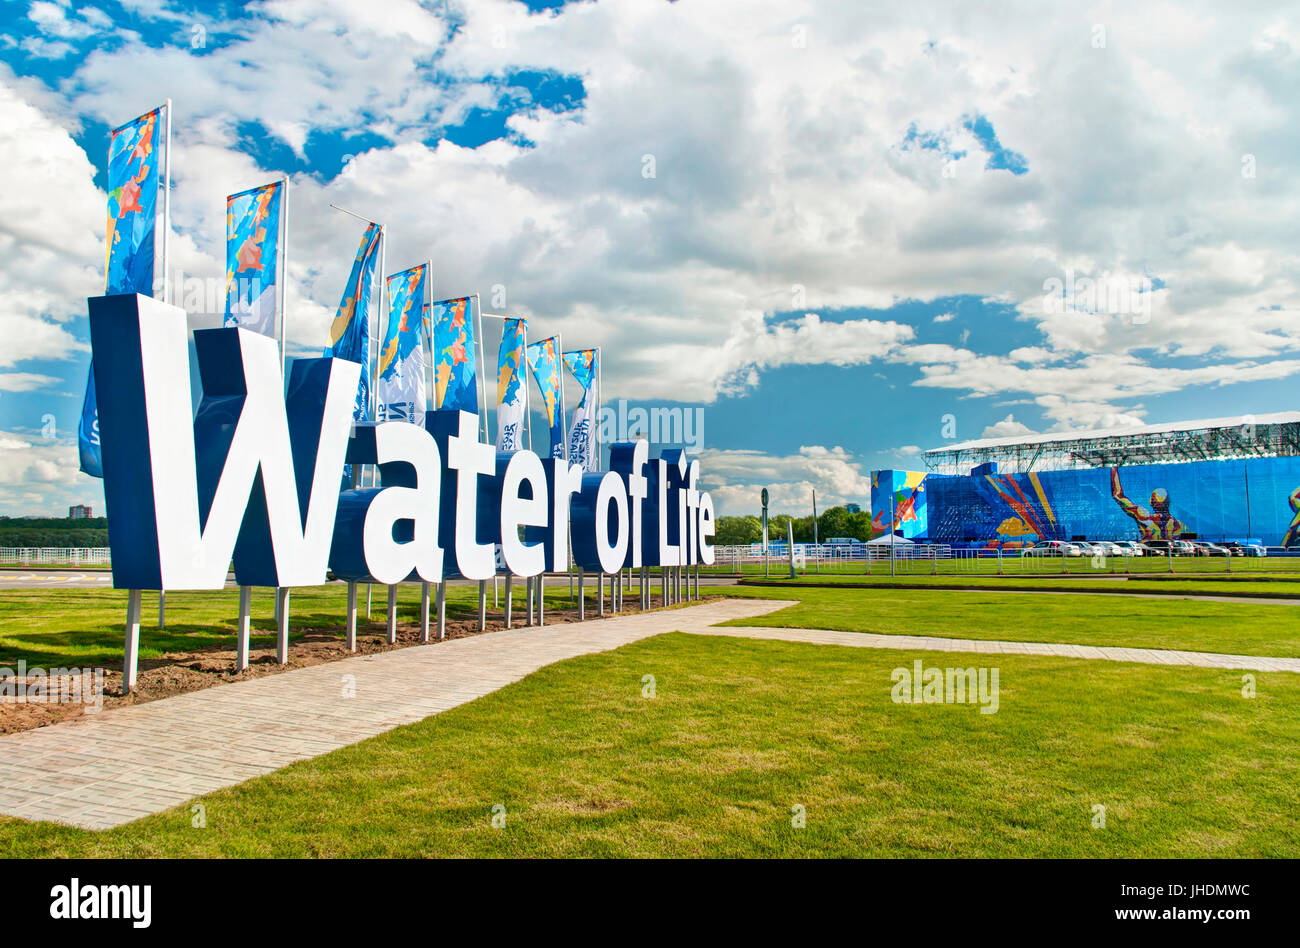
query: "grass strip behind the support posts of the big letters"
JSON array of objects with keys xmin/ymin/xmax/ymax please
[{"xmin": 0, "ymin": 579, "xmax": 594, "ymax": 666}]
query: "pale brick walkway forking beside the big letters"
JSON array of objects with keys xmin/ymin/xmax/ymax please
[{"xmin": 0, "ymin": 599, "xmax": 1300, "ymax": 830}]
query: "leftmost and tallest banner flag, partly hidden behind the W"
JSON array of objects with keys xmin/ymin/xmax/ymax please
[{"xmin": 77, "ymin": 105, "xmax": 172, "ymax": 477}]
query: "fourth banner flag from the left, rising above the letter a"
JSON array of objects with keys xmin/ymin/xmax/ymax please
[{"xmin": 378, "ymin": 263, "xmax": 429, "ymax": 425}]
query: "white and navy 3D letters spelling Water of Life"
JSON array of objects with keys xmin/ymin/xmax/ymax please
[{"xmin": 90, "ymin": 295, "xmax": 714, "ymax": 589}]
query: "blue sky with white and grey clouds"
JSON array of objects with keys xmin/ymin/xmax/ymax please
[{"xmin": 0, "ymin": 0, "xmax": 1300, "ymax": 514}]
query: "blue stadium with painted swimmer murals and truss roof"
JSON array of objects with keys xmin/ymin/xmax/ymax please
[{"xmin": 871, "ymin": 412, "xmax": 1300, "ymax": 549}]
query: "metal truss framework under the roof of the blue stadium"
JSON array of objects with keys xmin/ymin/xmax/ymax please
[{"xmin": 924, "ymin": 412, "xmax": 1300, "ymax": 475}]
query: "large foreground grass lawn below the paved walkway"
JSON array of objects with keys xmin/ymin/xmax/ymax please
[{"xmin": 0, "ymin": 633, "xmax": 1300, "ymax": 857}]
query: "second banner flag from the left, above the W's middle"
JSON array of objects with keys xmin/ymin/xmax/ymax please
[{"xmin": 222, "ymin": 181, "xmax": 286, "ymax": 337}]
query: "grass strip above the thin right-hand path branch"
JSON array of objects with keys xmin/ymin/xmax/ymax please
[{"xmin": 727, "ymin": 586, "xmax": 1300, "ymax": 658}]
